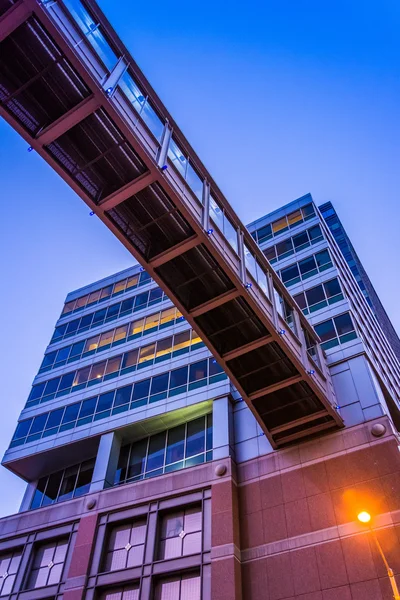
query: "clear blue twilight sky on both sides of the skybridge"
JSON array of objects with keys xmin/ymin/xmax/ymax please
[{"xmin": 0, "ymin": 0, "xmax": 400, "ymax": 515}]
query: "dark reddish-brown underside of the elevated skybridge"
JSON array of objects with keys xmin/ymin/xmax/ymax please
[{"xmin": 0, "ymin": 0, "xmax": 342, "ymax": 447}]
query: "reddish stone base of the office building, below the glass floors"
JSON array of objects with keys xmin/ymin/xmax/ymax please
[{"xmin": 0, "ymin": 418, "xmax": 400, "ymax": 600}]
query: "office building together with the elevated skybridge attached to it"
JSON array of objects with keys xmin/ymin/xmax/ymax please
[{"xmin": 0, "ymin": 0, "xmax": 400, "ymax": 600}]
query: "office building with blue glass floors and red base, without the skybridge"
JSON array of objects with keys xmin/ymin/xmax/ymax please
[{"xmin": 0, "ymin": 195, "xmax": 400, "ymax": 600}]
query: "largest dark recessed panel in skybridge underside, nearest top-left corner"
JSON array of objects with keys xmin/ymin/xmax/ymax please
[{"xmin": 0, "ymin": 17, "xmax": 90, "ymax": 135}]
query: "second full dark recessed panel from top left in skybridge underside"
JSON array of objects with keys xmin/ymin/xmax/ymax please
[{"xmin": 47, "ymin": 109, "xmax": 146, "ymax": 202}]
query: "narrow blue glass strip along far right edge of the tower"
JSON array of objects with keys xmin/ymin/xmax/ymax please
[{"xmin": 319, "ymin": 202, "xmax": 400, "ymax": 361}]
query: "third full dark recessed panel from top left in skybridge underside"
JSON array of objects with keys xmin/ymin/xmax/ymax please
[{"xmin": 107, "ymin": 184, "xmax": 194, "ymax": 260}]
